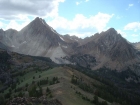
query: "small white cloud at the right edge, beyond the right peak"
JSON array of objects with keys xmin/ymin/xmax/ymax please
[{"xmin": 124, "ymin": 22, "xmax": 140, "ymax": 32}]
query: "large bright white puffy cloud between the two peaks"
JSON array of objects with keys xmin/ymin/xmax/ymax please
[{"xmin": 47, "ymin": 12, "xmax": 113, "ymax": 37}]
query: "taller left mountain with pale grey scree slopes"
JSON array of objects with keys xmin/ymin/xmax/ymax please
[{"xmin": 0, "ymin": 17, "xmax": 73, "ymax": 63}]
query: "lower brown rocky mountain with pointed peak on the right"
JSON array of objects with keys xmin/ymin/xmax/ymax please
[{"xmin": 67, "ymin": 28, "xmax": 139, "ymax": 71}]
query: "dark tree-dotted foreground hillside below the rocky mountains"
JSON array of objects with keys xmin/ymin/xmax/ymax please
[{"xmin": 0, "ymin": 50, "xmax": 140, "ymax": 105}]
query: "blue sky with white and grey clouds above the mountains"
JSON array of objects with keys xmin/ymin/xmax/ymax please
[{"xmin": 0, "ymin": 0, "xmax": 140, "ymax": 42}]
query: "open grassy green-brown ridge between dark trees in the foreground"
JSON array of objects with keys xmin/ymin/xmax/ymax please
[{"xmin": 0, "ymin": 67, "xmax": 109, "ymax": 105}]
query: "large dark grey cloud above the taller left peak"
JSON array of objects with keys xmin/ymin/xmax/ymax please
[{"xmin": 0, "ymin": 0, "xmax": 63, "ymax": 19}]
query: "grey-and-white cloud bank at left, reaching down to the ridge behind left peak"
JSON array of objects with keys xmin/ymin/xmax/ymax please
[{"xmin": 0, "ymin": 0, "xmax": 65, "ymax": 30}]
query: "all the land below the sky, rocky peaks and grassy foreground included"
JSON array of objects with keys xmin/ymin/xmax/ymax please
[{"xmin": 0, "ymin": 17, "xmax": 140, "ymax": 105}]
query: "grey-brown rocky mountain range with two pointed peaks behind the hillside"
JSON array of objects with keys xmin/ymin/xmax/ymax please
[{"xmin": 0, "ymin": 17, "xmax": 140, "ymax": 75}]
